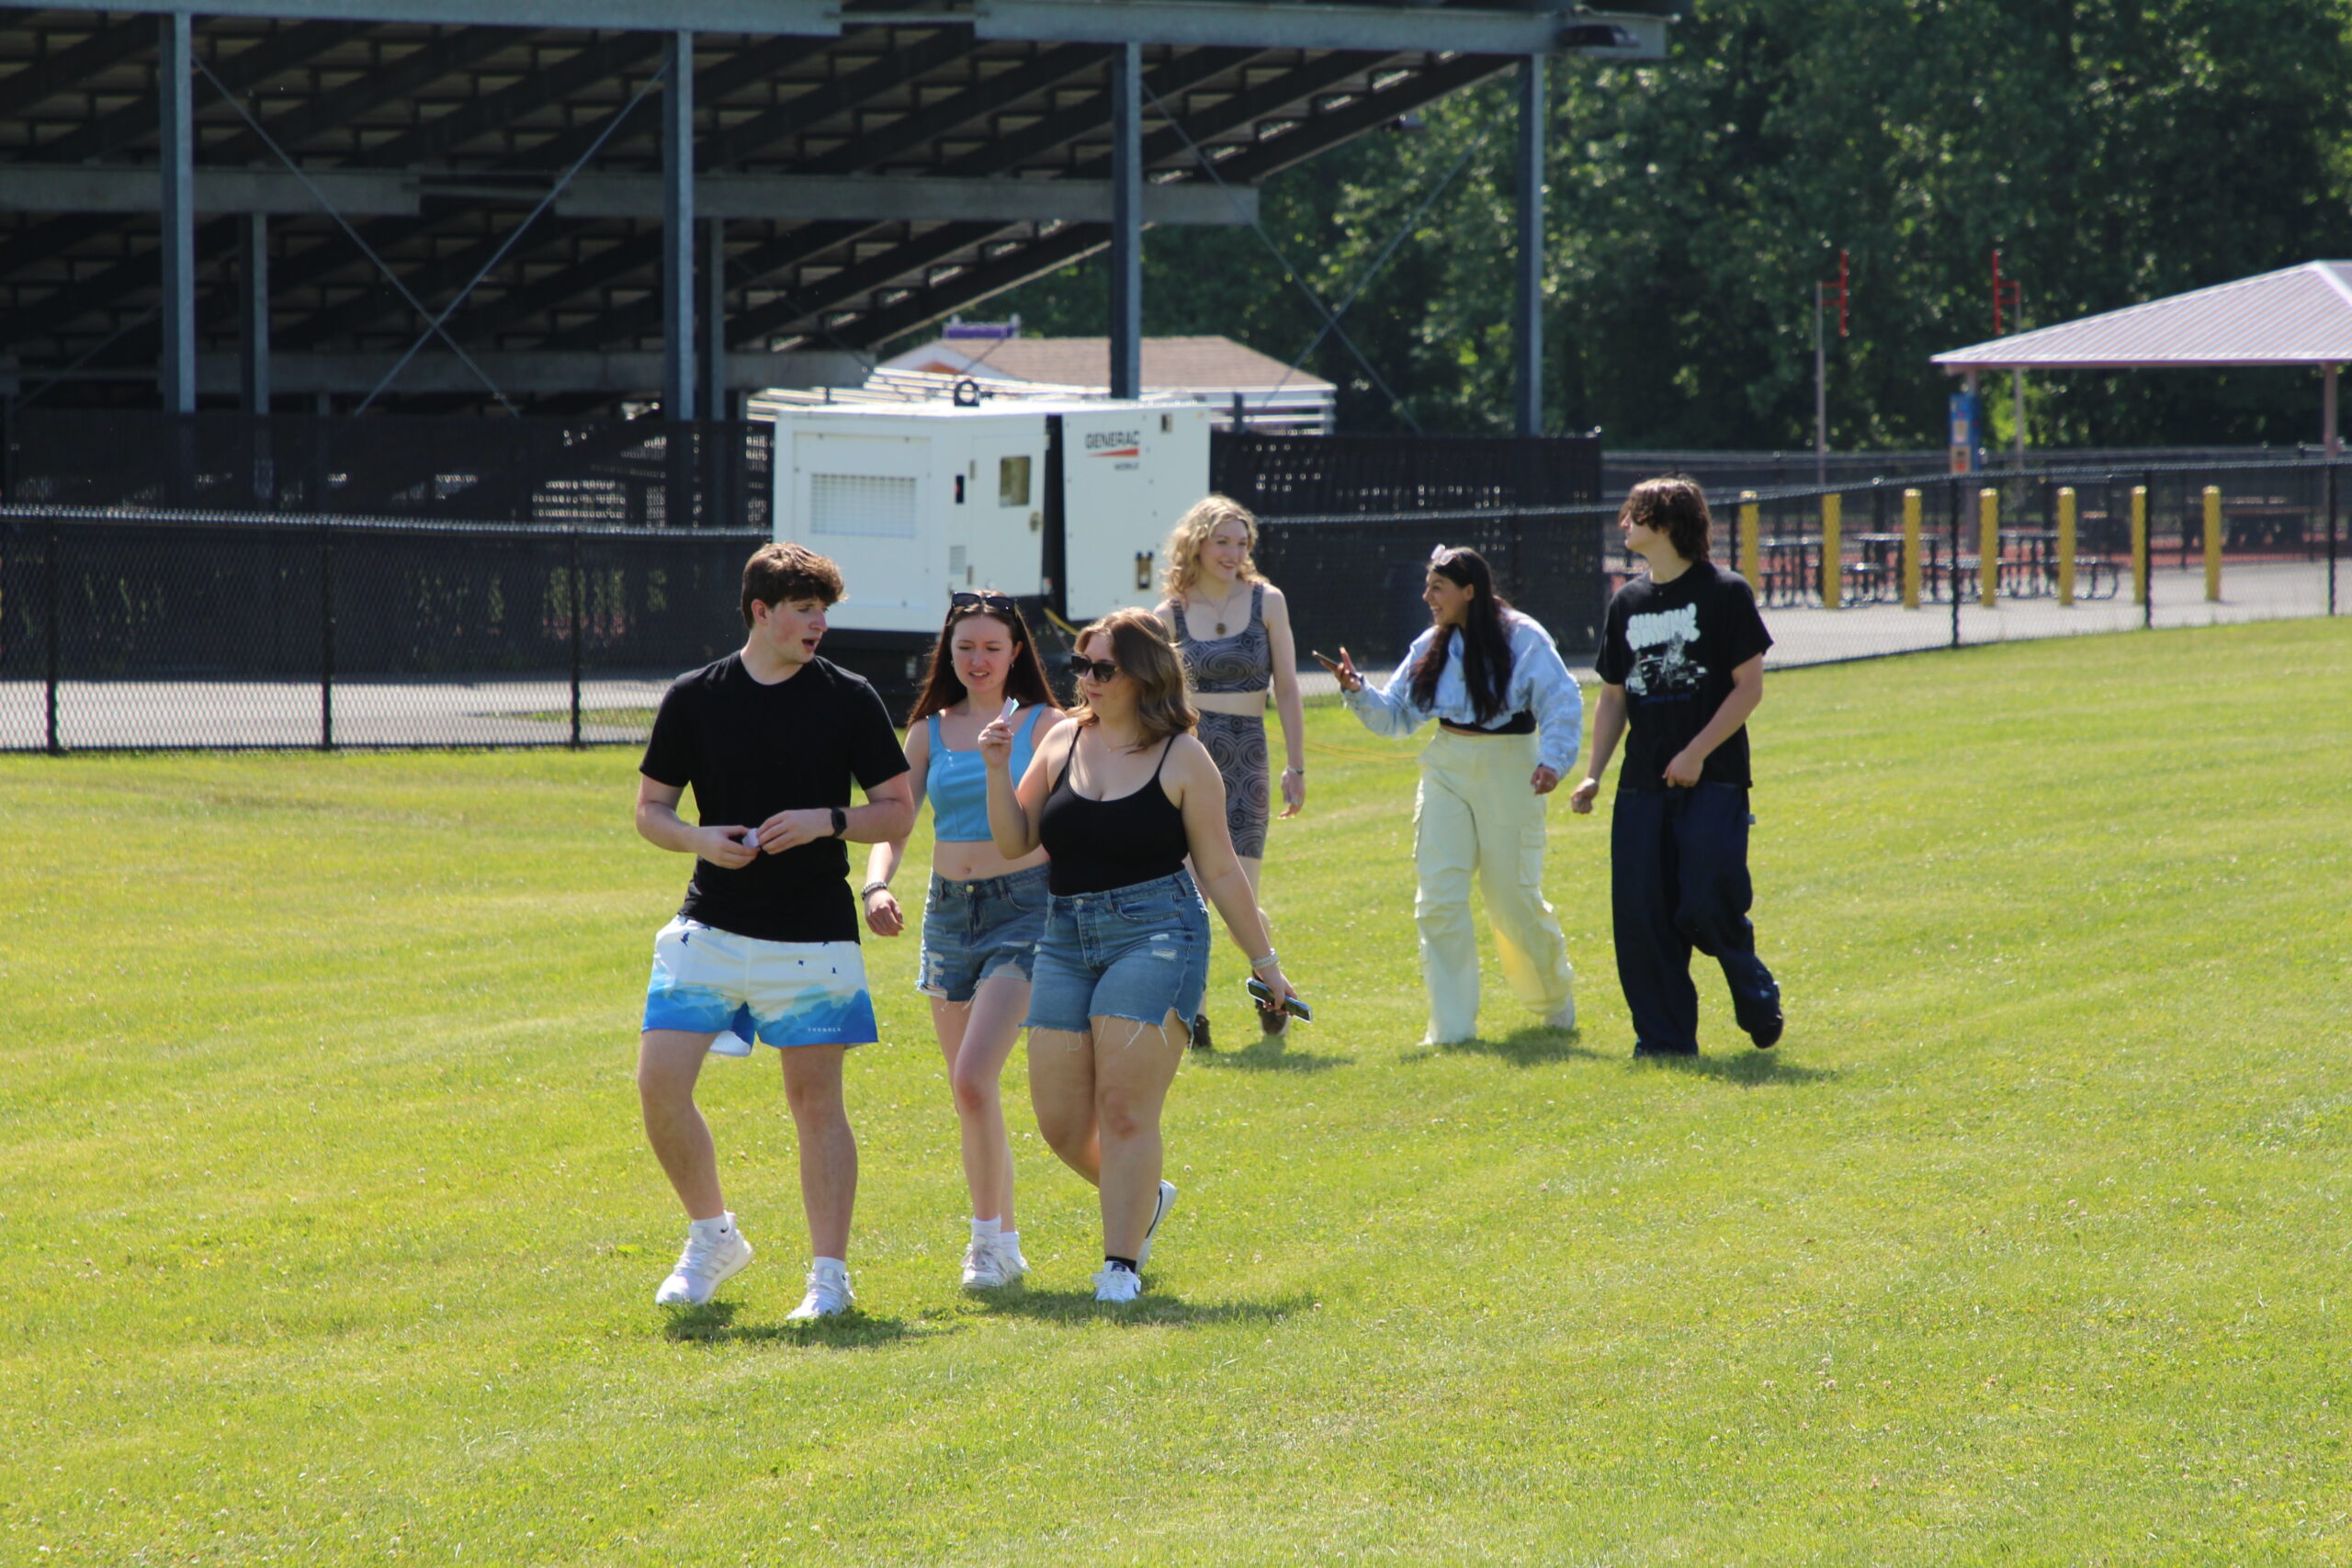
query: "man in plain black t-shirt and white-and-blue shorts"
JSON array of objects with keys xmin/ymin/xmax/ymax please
[{"xmin": 638, "ymin": 546, "xmax": 915, "ymax": 1319}]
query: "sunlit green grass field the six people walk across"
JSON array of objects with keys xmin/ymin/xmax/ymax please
[{"xmin": 0, "ymin": 623, "xmax": 2352, "ymax": 1563}]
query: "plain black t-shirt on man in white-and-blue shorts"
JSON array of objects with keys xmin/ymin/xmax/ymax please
[{"xmin": 638, "ymin": 653, "xmax": 906, "ymax": 942}]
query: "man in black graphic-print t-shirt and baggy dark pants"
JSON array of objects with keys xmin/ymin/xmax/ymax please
[{"xmin": 1569, "ymin": 478, "xmax": 1782, "ymax": 1055}]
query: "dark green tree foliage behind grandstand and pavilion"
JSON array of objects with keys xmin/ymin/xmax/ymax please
[{"xmin": 945, "ymin": 0, "xmax": 2352, "ymax": 446}]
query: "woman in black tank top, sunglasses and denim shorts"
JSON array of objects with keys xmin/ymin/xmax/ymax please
[{"xmin": 981, "ymin": 609, "xmax": 1296, "ymax": 1303}]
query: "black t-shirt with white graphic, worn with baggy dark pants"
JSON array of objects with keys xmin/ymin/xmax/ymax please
[{"xmin": 1592, "ymin": 562, "xmax": 1771, "ymax": 790}]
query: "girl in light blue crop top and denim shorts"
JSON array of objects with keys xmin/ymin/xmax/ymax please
[{"xmin": 858, "ymin": 592, "xmax": 1063, "ymax": 1291}]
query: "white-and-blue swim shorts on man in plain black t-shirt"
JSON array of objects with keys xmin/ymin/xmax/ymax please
[{"xmin": 644, "ymin": 915, "xmax": 882, "ymax": 1055}]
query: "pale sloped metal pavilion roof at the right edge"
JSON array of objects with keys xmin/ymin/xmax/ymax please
[{"xmin": 1933, "ymin": 261, "xmax": 2352, "ymax": 374}]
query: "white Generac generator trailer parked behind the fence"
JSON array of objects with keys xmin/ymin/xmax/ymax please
[{"xmin": 757, "ymin": 400, "xmax": 1211, "ymax": 694}]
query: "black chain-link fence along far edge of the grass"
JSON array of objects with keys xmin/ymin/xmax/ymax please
[{"xmin": 0, "ymin": 458, "xmax": 2347, "ymax": 752}]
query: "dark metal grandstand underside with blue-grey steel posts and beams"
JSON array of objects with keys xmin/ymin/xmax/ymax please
[{"xmin": 0, "ymin": 0, "xmax": 1677, "ymax": 419}]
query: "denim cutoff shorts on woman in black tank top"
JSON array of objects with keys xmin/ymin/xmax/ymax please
[{"xmin": 1028, "ymin": 872, "xmax": 1209, "ymax": 1032}]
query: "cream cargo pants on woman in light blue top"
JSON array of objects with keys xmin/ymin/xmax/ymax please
[{"xmin": 1414, "ymin": 728, "xmax": 1574, "ymax": 1043}]
